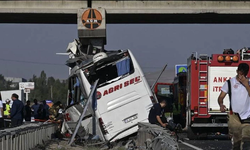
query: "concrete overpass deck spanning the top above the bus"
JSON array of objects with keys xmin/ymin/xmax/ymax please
[{"xmin": 0, "ymin": 0, "xmax": 250, "ymax": 24}]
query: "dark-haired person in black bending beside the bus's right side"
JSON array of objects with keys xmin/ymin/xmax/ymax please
[{"xmin": 148, "ymin": 100, "xmax": 168, "ymax": 128}]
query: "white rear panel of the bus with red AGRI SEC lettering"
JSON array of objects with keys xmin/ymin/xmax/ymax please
[{"xmin": 97, "ymin": 51, "xmax": 152, "ymax": 140}]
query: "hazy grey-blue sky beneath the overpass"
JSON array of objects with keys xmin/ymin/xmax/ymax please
[{"xmin": 0, "ymin": 24, "xmax": 250, "ymax": 79}]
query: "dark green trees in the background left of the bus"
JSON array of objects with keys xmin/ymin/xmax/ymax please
[{"xmin": 0, "ymin": 71, "xmax": 68, "ymax": 104}]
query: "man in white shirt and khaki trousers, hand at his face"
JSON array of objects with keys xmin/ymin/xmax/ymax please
[{"xmin": 218, "ymin": 63, "xmax": 250, "ymax": 150}]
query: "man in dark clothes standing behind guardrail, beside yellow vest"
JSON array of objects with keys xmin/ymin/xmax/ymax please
[{"xmin": 10, "ymin": 93, "xmax": 24, "ymax": 127}]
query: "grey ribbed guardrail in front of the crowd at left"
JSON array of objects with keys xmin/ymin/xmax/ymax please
[{"xmin": 0, "ymin": 123, "xmax": 57, "ymax": 150}]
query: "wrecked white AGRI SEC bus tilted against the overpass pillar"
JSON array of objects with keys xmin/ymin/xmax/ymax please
[{"xmin": 62, "ymin": 43, "xmax": 155, "ymax": 142}]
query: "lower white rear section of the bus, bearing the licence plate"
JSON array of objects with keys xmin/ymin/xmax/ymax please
[{"xmin": 101, "ymin": 94, "xmax": 152, "ymax": 140}]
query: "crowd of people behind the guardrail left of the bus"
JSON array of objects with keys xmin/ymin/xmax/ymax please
[{"xmin": 0, "ymin": 93, "xmax": 63, "ymax": 129}]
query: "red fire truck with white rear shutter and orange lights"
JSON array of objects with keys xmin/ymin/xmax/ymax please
[{"xmin": 186, "ymin": 48, "xmax": 250, "ymax": 139}]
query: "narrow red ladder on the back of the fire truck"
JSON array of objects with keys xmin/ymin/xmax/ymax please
[{"xmin": 198, "ymin": 54, "xmax": 209, "ymax": 116}]
